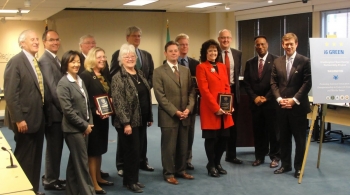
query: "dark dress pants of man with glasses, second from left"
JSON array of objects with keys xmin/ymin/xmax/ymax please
[{"xmin": 43, "ymin": 122, "xmax": 64, "ymax": 184}]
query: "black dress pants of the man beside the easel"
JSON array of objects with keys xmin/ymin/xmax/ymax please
[{"xmin": 277, "ymin": 109, "xmax": 307, "ymax": 170}]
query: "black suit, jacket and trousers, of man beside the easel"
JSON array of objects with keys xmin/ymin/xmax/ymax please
[{"xmin": 271, "ymin": 54, "xmax": 312, "ymax": 170}]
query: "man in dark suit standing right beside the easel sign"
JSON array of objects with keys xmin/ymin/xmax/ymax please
[{"xmin": 271, "ymin": 33, "xmax": 312, "ymax": 178}]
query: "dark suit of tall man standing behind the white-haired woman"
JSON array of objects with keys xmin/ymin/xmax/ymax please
[{"xmin": 110, "ymin": 49, "xmax": 154, "ymax": 170}]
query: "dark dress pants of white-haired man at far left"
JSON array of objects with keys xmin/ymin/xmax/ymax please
[{"xmin": 14, "ymin": 124, "xmax": 44, "ymax": 192}]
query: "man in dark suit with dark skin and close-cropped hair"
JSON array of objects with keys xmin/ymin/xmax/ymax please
[{"xmin": 243, "ymin": 36, "xmax": 280, "ymax": 168}]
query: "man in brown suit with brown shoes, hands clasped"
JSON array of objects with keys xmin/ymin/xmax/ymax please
[{"xmin": 153, "ymin": 41, "xmax": 195, "ymax": 185}]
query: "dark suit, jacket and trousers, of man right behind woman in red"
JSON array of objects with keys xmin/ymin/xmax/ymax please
[{"xmin": 218, "ymin": 48, "xmax": 242, "ymax": 159}]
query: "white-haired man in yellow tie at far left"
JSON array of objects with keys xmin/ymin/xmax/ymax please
[{"xmin": 4, "ymin": 30, "xmax": 50, "ymax": 194}]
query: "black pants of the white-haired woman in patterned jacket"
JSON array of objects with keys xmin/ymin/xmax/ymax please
[{"xmin": 116, "ymin": 127, "xmax": 140, "ymax": 185}]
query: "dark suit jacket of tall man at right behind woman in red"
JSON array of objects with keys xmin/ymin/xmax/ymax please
[{"xmin": 218, "ymin": 48, "xmax": 242, "ymax": 103}]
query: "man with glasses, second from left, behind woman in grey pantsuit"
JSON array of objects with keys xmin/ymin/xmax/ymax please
[{"xmin": 39, "ymin": 30, "xmax": 65, "ymax": 190}]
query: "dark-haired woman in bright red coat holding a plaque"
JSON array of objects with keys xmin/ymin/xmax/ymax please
[{"xmin": 196, "ymin": 39, "xmax": 233, "ymax": 177}]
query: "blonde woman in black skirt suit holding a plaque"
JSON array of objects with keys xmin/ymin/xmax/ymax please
[{"xmin": 80, "ymin": 47, "xmax": 114, "ymax": 194}]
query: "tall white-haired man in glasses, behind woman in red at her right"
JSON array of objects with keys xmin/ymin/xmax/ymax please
[{"xmin": 218, "ymin": 29, "xmax": 243, "ymax": 164}]
